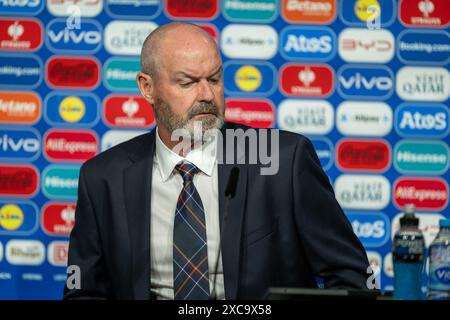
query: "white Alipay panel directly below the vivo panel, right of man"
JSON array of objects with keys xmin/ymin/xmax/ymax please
[{"xmin": 336, "ymin": 101, "xmax": 393, "ymax": 136}]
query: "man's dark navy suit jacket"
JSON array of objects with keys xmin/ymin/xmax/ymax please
[{"xmin": 64, "ymin": 123, "xmax": 369, "ymax": 299}]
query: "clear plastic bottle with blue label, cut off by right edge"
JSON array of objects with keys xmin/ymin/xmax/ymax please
[{"xmin": 427, "ymin": 219, "xmax": 450, "ymax": 300}]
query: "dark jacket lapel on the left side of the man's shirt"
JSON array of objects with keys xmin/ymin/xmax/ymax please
[{"xmin": 123, "ymin": 130, "xmax": 155, "ymax": 300}]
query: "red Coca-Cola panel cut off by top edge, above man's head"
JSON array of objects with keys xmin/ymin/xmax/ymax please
[{"xmin": 164, "ymin": 0, "xmax": 219, "ymax": 20}]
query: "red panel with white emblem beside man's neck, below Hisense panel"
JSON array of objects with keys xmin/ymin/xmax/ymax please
[{"xmin": 103, "ymin": 95, "xmax": 155, "ymax": 128}]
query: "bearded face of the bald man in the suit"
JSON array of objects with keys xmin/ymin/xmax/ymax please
[{"xmin": 148, "ymin": 35, "xmax": 225, "ymax": 136}]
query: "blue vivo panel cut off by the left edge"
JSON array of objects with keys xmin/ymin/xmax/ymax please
[{"xmin": 0, "ymin": 128, "xmax": 41, "ymax": 161}]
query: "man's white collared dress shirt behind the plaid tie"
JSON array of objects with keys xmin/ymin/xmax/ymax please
[{"xmin": 150, "ymin": 129, "xmax": 225, "ymax": 299}]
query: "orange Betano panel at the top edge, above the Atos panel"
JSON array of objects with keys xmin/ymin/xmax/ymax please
[{"xmin": 281, "ymin": 0, "xmax": 337, "ymax": 24}]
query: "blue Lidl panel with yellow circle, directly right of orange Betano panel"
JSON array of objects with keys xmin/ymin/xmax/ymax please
[{"xmin": 45, "ymin": 93, "xmax": 100, "ymax": 126}]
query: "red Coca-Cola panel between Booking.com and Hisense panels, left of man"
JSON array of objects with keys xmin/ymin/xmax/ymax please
[{"xmin": 46, "ymin": 57, "xmax": 100, "ymax": 89}]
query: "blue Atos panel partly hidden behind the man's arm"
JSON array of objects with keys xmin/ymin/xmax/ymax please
[{"xmin": 346, "ymin": 212, "xmax": 391, "ymax": 248}]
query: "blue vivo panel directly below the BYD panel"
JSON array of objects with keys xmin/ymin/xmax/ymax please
[{"xmin": 338, "ymin": 65, "xmax": 394, "ymax": 100}]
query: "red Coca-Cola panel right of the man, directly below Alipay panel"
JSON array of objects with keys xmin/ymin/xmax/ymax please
[{"xmin": 336, "ymin": 139, "xmax": 391, "ymax": 172}]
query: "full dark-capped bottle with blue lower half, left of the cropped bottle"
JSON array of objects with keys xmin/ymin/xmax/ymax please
[{"xmin": 392, "ymin": 204, "xmax": 425, "ymax": 300}]
